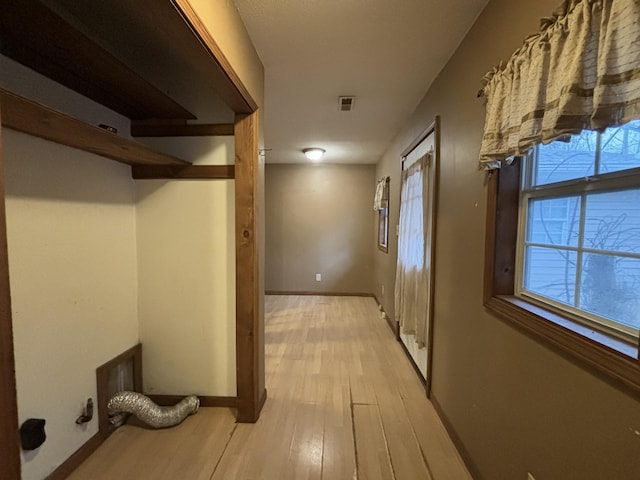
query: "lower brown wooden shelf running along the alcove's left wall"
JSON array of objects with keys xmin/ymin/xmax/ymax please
[{"xmin": 0, "ymin": 89, "xmax": 190, "ymax": 166}]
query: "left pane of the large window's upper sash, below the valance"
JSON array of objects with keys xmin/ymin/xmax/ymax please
[{"xmin": 532, "ymin": 130, "xmax": 598, "ymax": 185}]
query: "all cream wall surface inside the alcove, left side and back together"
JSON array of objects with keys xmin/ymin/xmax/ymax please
[{"xmin": 0, "ymin": 52, "xmax": 236, "ymax": 480}]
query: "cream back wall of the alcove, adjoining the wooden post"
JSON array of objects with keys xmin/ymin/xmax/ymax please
[{"xmin": 137, "ymin": 137, "xmax": 236, "ymax": 396}]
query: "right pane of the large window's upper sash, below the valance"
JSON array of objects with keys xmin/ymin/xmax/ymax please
[{"xmin": 600, "ymin": 120, "xmax": 640, "ymax": 173}]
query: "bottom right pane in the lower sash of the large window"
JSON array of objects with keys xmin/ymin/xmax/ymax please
[{"xmin": 580, "ymin": 254, "xmax": 640, "ymax": 328}]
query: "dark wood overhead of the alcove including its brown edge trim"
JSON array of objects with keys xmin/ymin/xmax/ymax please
[{"xmin": 0, "ymin": 0, "xmax": 257, "ymax": 121}]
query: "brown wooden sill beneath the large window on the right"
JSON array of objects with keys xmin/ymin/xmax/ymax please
[{"xmin": 485, "ymin": 295, "xmax": 640, "ymax": 390}]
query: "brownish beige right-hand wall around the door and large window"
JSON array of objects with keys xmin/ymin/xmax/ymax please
[{"xmin": 375, "ymin": 0, "xmax": 640, "ymax": 480}]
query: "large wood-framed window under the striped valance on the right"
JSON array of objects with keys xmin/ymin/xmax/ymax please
[{"xmin": 485, "ymin": 120, "xmax": 640, "ymax": 386}]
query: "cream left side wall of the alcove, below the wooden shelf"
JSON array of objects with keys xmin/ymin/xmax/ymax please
[{"xmin": 2, "ymin": 129, "xmax": 138, "ymax": 480}]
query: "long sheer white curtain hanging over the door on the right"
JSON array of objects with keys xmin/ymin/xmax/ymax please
[{"xmin": 395, "ymin": 154, "xmax": 431, "ymax": 347}]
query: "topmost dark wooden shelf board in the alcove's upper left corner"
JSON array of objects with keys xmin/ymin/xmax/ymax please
[{"xmin": 0, "ymin": 0, "xmax": 196, "ymax": 119}]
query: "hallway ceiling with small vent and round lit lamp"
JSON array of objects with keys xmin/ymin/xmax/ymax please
[{"xmin": 235, "ymin": 0, "xmax": 487, "ymax": 164}]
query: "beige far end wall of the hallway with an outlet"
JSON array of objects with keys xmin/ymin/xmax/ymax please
[{"xmin": 265, "ymin": 164, "xmax": 377, "ymax": 293}]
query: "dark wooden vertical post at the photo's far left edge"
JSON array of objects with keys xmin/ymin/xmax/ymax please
[{"xmin": 0, "ymin": 99, "xmax": 20, "ymax": 480}]
